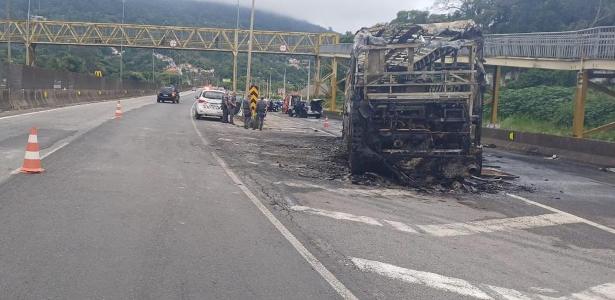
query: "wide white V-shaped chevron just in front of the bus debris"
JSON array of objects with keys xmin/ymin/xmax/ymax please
[{"xmin": 291, "ymin": 206, "xmax": 580, "ymax": 237}]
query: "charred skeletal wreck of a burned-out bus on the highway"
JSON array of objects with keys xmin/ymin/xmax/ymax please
[{"xmin": 344, "ymin": 21, "xmax": 485, "ymax": 181}]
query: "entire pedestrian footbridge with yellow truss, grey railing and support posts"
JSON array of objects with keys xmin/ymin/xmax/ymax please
[{"xmin": 0, "ymin": 20, "xmax": 615, "ymax": 137}]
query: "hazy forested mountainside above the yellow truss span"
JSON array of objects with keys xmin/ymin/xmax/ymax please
[{"xmin": 0, "ymin": 0, "xmax": 326, "ymax": 32}]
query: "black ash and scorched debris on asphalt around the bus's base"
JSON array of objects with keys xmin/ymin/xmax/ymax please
[{"xmin": 213, "ymin": 119, "xmax": 533, "ymax": 194}]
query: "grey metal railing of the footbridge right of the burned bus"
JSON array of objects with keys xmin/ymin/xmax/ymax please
[{"xmin": 485, "ymin": 26, "xmax": 615, "ymax": 60}]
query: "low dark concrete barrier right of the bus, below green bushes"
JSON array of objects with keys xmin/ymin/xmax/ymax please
[{"xmin": 483, "ymin": 128, "xmax": 615, "ymax": 166}]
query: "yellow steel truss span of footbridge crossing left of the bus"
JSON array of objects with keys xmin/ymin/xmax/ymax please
[{"xmin": 0, "ymin": 20, "xmax": 339, "ymax": 55}]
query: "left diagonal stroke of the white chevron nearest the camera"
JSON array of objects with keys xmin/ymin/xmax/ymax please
[{"xmin": 350, "ymin": 257, "xmax": 492, "ymax": 300}]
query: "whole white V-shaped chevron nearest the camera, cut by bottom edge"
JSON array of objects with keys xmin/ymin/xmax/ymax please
[{"xmin": 350, "ymin": 257, "xmax": 615, "ymax": 300}]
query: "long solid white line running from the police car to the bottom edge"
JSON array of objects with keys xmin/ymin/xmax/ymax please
[{"xmin": 190, "ymin": 108, "xmax": 358, "ymax": 300}]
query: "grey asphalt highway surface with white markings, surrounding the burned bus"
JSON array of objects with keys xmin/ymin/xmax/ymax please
[{"xmin": 0, "ymin": 93, "xmax": 615, "ymax": 299}]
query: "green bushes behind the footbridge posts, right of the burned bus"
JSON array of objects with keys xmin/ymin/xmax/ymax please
[{"xmin": 484, "ymin": 70, "xmax": 615, "ymax": 141}]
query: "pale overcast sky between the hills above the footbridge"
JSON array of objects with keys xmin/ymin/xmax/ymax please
[{"xmin": 215, "ymin": 0, "xmax": 434, "ymax": 32}]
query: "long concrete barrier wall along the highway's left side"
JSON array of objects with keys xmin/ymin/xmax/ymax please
[{"xmin": 0, "ymin": 89, "xmax": 153, "ymax": 112}]
